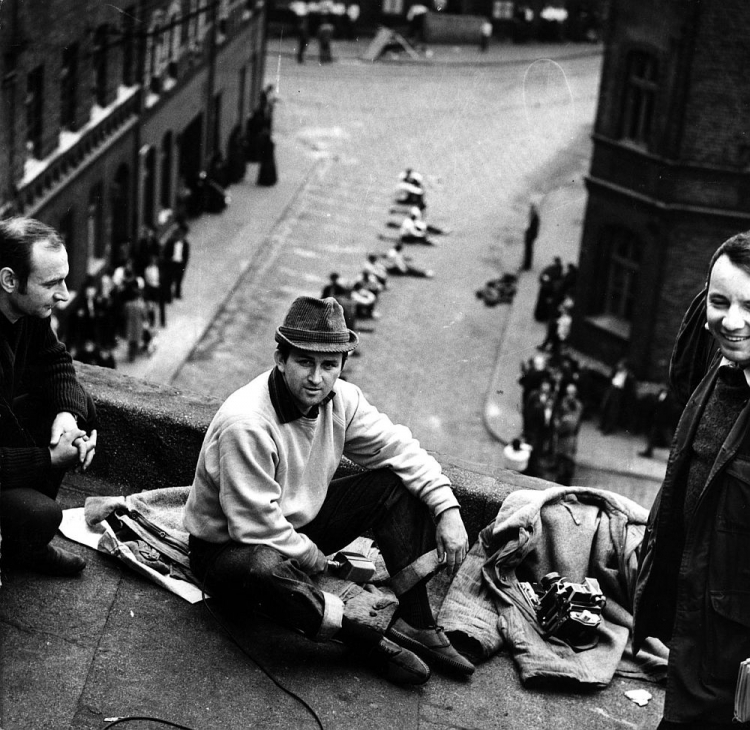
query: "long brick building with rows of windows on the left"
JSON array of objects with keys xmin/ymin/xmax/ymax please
[{"xmin": 0, "ymin": 0, "xmax": 266, "ymax": 320}]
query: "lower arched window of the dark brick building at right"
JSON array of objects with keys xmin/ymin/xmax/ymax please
[{"xmin": 602, "ymin": 228, "xmax": 643, "ymax": 322}]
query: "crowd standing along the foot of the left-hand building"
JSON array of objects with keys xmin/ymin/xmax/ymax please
[{"xmin": 64, "ymin": 84, "xmax": 277, "ymax": 368}]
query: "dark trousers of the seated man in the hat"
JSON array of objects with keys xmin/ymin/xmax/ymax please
[{"xmin": 190, "ymin": 469, "xmax": 435, "ymax": 639}]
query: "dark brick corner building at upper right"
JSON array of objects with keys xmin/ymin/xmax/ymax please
[{"xmin": 573, "ymin": 0, "xmax": 750, "ymax": 380}]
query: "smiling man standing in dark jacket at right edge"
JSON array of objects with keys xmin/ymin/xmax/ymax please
[{"xmin": 634, "ymin": 233, "xmax": 750, "ymax": 730}]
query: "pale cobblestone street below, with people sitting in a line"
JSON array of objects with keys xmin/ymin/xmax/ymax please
[{"xmin": 173, "ymin": 43, "xmax": 600, "ymax": 466}]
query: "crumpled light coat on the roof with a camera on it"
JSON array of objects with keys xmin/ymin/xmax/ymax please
[{"xmin": 439, "ymin": 487, "xmax": 666, "ymax": 687}]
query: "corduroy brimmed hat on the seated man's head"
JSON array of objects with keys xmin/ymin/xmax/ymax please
[{"xmin": 274, "ymin": 297, "xmax": 359, "ymax": 352}]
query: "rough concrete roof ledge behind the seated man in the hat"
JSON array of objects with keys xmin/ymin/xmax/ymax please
[{"xmin": 75, "ymin": 363, "xmax": 550, "ymax": 543}]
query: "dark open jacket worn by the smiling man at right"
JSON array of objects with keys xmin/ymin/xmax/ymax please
[{"xmin": 633, "ymin": 298, "xmax": 750, "ymax": 722}]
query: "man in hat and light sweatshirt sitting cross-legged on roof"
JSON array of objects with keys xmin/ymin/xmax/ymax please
[{"xmin": 185, "ymin": 297, "xmax": 474, "ymax": 685}]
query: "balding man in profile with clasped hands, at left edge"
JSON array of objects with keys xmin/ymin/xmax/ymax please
[{"xmin": 0, "ymin": 218, "xmax": 96, "ymax": 575}]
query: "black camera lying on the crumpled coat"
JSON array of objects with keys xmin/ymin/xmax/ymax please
[{"xmin": 519, "ymin": 573, "xmax": 607, "ymax": 651}]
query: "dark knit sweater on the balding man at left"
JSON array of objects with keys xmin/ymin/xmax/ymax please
[{"xmin": 0, "ymin": 314, "xmax": 90, "ymax": 489}]
